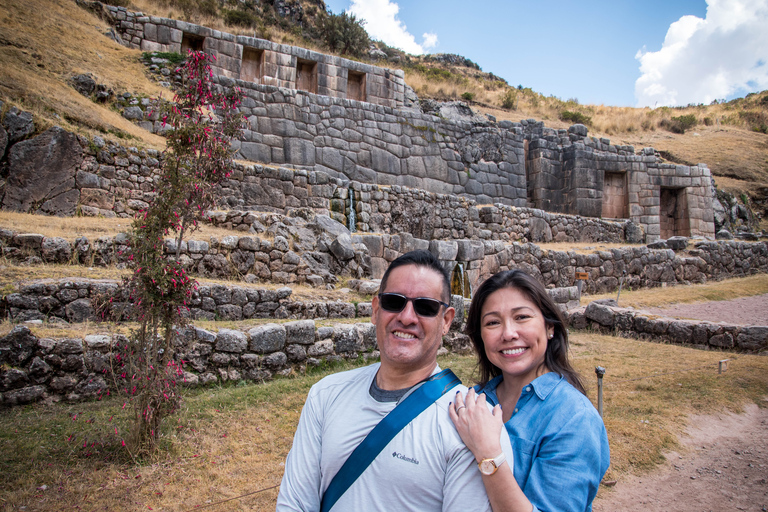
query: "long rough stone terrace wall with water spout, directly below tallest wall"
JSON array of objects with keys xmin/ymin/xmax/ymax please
[{"xmin": 0, "ymin": 128, "xmax": 643, "ymax": 242}]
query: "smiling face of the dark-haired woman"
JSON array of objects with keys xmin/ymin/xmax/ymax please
[{"xmin": 480, "ymin": 288, "xmax": 554, "ymax": 385}]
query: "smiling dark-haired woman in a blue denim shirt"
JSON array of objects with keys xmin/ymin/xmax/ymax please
[{"xmin": 449, "ymin": 270, "xmax": 610, "ymax": 512}]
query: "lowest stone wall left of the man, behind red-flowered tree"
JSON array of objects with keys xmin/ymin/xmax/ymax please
[{"xmin": 0, "ymin": 320, "xmax": 376, "ymax": 406}]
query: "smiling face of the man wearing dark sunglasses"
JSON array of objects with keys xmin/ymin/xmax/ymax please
[{"xmin": 371, "ymin": 265, "xmax": 456, "ymax": 378}]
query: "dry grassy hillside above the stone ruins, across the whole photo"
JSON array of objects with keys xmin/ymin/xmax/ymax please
[{"xmin": 0, "ymin": 0, "xmax": 768, "ymax": 225}]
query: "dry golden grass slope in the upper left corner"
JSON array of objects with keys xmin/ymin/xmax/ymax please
[{"xmin": 0, "ymin": 0, "xmax": 169, "ymax": 148}]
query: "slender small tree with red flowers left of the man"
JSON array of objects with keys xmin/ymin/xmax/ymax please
[{"xmin": 114, "ymin": 52, "xmax": 243, "ymax": 455}]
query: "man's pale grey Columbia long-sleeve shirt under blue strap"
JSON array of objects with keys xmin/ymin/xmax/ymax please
[{"xmin": 277, "ymin": 363, "xmax": 504, "ymax": 512}]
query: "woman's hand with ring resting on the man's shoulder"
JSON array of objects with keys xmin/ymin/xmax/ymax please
[{"xmin": 448, "ymin": 388, "xmax": 504, "ymax": 460}]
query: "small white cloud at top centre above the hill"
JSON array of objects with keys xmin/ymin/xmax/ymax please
[{"xmin": 347, "ymin": 0, "xmax": 437, "ymax": 55}]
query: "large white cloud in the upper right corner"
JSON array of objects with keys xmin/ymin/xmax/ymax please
[{"xmin": 635, "ymin": 0, "xmax": 768, "ymax": 107}]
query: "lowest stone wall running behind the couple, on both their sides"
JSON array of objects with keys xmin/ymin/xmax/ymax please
[{"xmin": 0, "ymin": 288, "xmax": 768, "ymax": 406}]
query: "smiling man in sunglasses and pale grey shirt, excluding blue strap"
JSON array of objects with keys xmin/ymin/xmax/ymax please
[{"xmin": 277, "ymin": 251, "xmax": 509, "ymax": 512}]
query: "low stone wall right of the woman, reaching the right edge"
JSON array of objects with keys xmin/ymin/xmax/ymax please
[{"xmin": 568, "ymin": 302, "xmax": 768, "ymax": 353}]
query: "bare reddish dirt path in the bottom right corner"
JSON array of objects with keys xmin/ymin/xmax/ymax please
[{"xmin": 593, "ymin": 399, "xmax": 768, "ymax": 512}]
